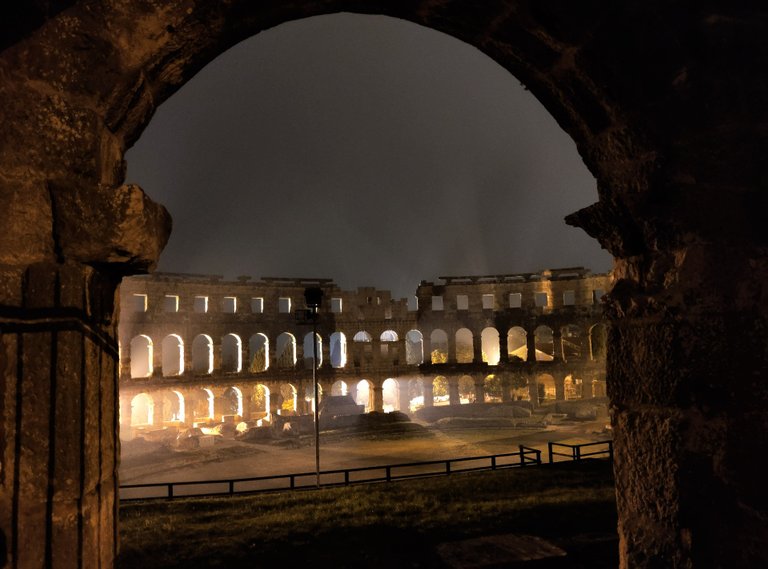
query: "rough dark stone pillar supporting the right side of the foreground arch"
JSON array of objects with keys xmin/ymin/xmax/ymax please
[{"xmin": 607, "ymin": 245, "xmax": 768, "ymax": 567}]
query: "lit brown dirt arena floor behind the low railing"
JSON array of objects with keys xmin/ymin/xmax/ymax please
[{"xmin": 120, "ymin": 412, "xmax": 611, "ymax": 484}]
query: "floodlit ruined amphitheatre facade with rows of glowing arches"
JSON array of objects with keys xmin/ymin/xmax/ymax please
[{"xmin": 119, "ymin": 268, "xmax": 610, "ymax": 437}]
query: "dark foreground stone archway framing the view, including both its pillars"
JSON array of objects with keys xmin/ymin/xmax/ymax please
[{"xmin": 0, "ymin": 0, "xmax": 768, "ymax": 567}]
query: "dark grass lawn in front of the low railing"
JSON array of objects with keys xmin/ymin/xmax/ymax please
[{"xmin": 118, "ymin": 460, "xmax": 618, "ymax": 569}]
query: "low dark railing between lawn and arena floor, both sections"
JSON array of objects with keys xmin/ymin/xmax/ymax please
[{"xmin": 120, "ymin": 441, "xmax": 613, "ymax": 501}]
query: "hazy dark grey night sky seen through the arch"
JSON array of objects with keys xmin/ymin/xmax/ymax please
[{"xmin": 127, "ymin": 14, "xmax": 611, "ymax": 296}]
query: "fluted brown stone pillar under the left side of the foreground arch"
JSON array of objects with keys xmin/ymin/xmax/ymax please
[{"xmin": 0, "ymin": 264, "xmax": 120, "ymax": 568}]
